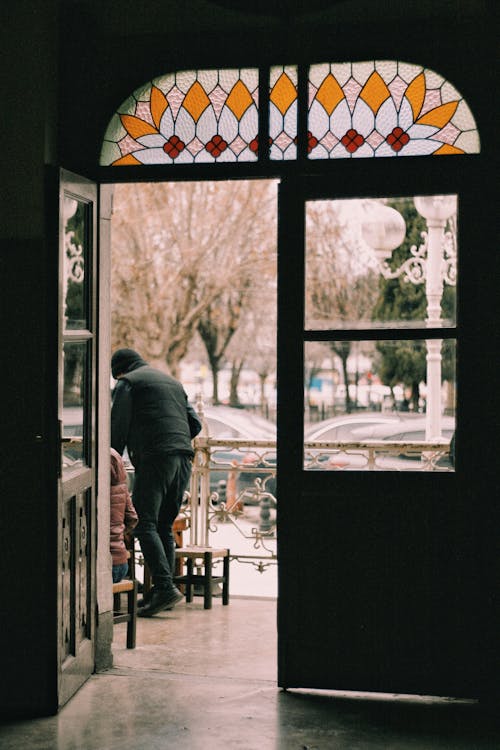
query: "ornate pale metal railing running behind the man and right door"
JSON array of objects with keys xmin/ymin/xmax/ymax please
[{"xmin": 181, "ymin": 436, "xmax": 453, "ymax": 572}]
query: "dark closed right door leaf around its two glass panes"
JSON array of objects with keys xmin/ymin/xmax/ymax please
[{"xmin": 277, "ymin": 158, "xmax": 497, "ymax": 696}]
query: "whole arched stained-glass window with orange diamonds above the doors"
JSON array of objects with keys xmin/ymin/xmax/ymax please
[{"xmin": 100, "ymin": 60, "xmax": 480, "ymax": 166}]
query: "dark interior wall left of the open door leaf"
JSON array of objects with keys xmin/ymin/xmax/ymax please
[{"xmin": 0, "ymin": 0, "xmax": 58, "ymax": 715}]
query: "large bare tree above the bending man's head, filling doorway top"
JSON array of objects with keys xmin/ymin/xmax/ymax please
[{"xmin": 111, "ymin": 181, "xmax": 275, "ymax": 375}]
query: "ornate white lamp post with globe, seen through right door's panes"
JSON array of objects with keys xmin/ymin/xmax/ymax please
[{"xmin": 362, "ymin": 200, "xmax": 456, "ymax": 440}]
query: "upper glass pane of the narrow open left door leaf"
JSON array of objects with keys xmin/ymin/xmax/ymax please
[{"xmin": 63, "ymin": 195, "xmax": 90, "ymax": 329}]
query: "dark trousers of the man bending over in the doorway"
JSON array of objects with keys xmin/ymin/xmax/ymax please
[{"xmin": 133, "ymin": 455, "xmax": 191, "ymax": 590}]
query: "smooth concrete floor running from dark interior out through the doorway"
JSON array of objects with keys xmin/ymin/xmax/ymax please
[{"xmin": 0, "ymin": 596, "xmax": 500, "ymax": 750}]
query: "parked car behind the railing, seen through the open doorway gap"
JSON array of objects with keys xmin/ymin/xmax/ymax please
[{"xmin": 199, "ymin": 406, "xmax": 276, "ymax": 505}]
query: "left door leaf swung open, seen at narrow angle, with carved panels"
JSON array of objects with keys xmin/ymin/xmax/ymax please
[{"xmin": 58, "ymin": 171, "xmax": 97, "ymax": 706}]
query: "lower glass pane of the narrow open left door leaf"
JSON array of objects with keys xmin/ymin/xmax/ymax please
[{"xmin": 62, "ymin": 342, "xmax": 89, "ymax": 470}]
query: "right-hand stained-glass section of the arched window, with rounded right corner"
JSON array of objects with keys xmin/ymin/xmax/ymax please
[{"xmin": 308, "ymin": 60, "xmax": 480, "ymax": 159}]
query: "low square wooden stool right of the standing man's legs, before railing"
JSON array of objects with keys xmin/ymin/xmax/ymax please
[{"xmin": 174, "ymin": 547, "xmax": 230, "ymax": 609}]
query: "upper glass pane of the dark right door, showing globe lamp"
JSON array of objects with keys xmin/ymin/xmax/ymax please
[{"xmin": 305, "ymin": 195, "xmax": 457, "ymax": 330}]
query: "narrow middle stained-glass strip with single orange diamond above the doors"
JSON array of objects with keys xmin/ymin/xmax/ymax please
[{"xmin": 269, "ymin": 65, "xmax": 297, "ymax": 161}]
